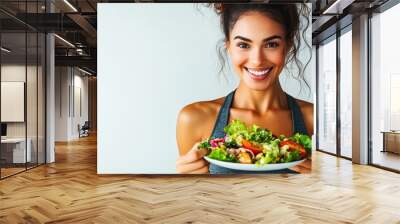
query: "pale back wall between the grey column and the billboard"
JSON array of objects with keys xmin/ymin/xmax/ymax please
[{"xmin": 55, "ymin": 67, "xmax": 88, "ymax": 141}]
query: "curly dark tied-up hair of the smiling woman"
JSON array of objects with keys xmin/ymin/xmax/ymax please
[{"xmin": 206, "ymin": 3, "xmax": 312, "ymax": 95}]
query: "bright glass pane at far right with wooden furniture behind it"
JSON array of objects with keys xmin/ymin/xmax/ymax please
[{"xmin": 370, "ymin": 4, "xmax": 400, "ymax": 171}]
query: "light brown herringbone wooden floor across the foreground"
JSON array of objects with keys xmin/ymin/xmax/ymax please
[{"xmin": 0, "ymin": 134, "xmax": 400, "ymax": 224}]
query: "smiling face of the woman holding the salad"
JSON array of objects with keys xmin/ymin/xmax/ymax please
[{"xmin": 226, "ymin": 12, "xmax": 286, "ymax": 90}]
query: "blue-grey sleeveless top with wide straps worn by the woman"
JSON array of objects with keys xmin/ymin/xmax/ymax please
[{"xmin": 209, "ymin": 90, "xmax": 308, "ymax": 174}]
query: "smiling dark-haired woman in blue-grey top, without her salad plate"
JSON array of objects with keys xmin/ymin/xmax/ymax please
[{"xmin": 176, "ymin": 3, "xmax": 313, "ymax": 174}]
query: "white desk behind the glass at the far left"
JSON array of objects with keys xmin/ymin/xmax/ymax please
[{"xmin": 1, "ymin": 138, "xmax": 32, "ymax": 163}]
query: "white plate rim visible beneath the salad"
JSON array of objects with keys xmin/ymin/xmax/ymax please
[{"xmin": 204, "ymin": 156, "xmax": 306, "ymax": 171}]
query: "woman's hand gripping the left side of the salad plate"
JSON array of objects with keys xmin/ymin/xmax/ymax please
[{"xmin": 176, "ymin": 143, "xmax": 209, "ymax": 174}]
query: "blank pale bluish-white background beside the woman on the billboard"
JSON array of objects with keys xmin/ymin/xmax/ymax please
[{"xmin": 97, "ymin": 4, "xmax": 313, "ymax": 174}]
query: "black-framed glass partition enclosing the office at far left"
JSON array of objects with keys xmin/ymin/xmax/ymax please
[{"xmin": 0, "ymin": 1, "xmax": 46, "ymax": 179}]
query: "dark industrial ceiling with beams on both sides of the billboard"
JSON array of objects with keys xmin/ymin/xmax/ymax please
[{"xmin": 0, "ymin": 0, "xmax": 394, "ymax": 73}]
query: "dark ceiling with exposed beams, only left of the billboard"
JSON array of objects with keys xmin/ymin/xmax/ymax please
[{"xmin": 0, "ymin": 0, "xmax": 100, "ymax": 74}]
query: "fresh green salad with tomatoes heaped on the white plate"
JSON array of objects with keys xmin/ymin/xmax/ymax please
[{"xmin": 198, "ymin": 120, "xmax": 312, "ymax": 165}]
